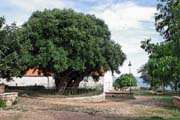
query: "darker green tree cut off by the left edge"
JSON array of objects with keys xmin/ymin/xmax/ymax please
[{"xmin": 0, "ymin": 17, "xmax": 30, "ymax": 80}]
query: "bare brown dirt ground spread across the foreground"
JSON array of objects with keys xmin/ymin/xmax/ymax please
[{"xmin": 0, "ymin": 96, "xmax": 178, "ymax": 120}]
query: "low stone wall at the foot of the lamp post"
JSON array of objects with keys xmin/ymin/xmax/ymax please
[{"xmin": 105, "ymin": 92, "xmax": 135, "ymax": 99}]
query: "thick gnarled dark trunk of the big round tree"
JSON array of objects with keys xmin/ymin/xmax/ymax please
[{"xmin": 54, "ymin": 66, "xmax": 104, "ymax": 94}]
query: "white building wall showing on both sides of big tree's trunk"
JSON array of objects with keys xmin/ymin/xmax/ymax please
[{"xmin": 0, "ymin": 71, "xmax": 113, "ymax": 93}]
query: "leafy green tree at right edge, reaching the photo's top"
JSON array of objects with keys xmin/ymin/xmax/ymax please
[{"xmin": 141, "ymin": 0, "xmax": 180, "ymax": 90}]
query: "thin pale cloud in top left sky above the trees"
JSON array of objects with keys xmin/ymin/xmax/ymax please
[{"xmin": 3, "ymin": 0, "xmax": 74, "ymax": 25}]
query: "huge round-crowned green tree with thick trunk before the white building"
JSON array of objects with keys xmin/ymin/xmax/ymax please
[{"xmin": 19, "ymin": 9, "xmax": 126, "ymax": 94}]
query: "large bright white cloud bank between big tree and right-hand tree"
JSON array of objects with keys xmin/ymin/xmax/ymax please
[{"xmin": 89, "ymin": 2, "xmax": 161, "ymax": 75}]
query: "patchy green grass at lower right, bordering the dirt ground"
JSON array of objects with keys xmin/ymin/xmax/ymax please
[{"xmin": 135, "ymin": 90, "xmax": 180, "ymax": 120}]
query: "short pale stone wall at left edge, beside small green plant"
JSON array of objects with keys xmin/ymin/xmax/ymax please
[{"xmin": 0, "ymin": 92, "xmax": 18, "ymax": 106}]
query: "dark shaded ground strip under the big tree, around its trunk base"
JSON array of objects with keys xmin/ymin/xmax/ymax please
[{"xmin": 6, "ymin": 86, "xmax": 102, "ymax": 97}]
